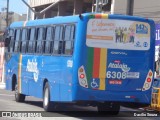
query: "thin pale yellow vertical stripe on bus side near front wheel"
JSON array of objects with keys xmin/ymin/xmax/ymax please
[{"xmin": 18, "ymin": 54, "xmax": 22, "ymax": 93}]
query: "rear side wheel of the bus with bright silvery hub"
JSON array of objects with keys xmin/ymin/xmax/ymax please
[{"xmin": 43, "ymin": 82, "xmax": 54, "ymax": 112}]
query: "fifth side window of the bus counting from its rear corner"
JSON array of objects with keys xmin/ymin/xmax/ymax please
[{"xmin": 28, "ymin": 28, "xmax": 36, "ymax": 53}]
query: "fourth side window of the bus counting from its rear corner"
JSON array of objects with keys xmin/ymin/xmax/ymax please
[{"xmin": 36, "ymin": 28, "xmax": 45, "ymax": 53}]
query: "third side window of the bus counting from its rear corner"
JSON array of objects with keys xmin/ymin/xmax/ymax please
[{"xmin": 44, "ymin": 27, "xmax": 54, "ymax": 54}]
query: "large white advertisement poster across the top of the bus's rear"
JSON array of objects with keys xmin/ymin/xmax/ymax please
[{"xmin": 86, "ymin": 19, "xmax": 150, "ymax": 50}]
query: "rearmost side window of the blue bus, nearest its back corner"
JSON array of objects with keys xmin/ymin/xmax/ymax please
[{"xmin": 64, "ymin": 25, "xmax": 75, "ymax": 55}]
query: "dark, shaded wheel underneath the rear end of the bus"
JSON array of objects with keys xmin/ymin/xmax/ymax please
[{"xmin": 97, "ymin": 102, "xmax": 120, "ymax": 115}]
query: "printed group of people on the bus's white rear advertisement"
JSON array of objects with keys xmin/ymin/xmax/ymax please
[{"xmin": 115, "ymin": 27, "xmax": 135, "ymax": 43}]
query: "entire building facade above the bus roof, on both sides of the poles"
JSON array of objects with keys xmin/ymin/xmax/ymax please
[{"xmin": 29, "ymin": 0, "xmax": 160, "ymax": 22}]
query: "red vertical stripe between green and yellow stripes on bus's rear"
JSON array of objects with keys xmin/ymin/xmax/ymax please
[{"xmin": 93, "ymin": 48, "xmax": 101, "ymax": 78}]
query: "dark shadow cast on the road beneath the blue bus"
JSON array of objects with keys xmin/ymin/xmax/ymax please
[{"xmin": 22, "ymin": 101, "xmax": 133, "ymax": 119}]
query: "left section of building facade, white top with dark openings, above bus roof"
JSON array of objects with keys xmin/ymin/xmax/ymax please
[{"xmin": 29, "ymin": 0, "xmax": 95, "ymax": 19}]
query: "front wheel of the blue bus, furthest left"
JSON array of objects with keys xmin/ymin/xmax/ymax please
[{"xmin": 15, "ymin": 84, "xmax": 25, "ymax": 102}]
